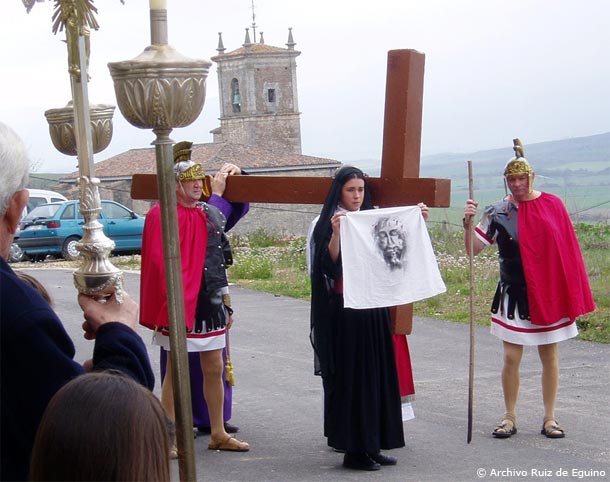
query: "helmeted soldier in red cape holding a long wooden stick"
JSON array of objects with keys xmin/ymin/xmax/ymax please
[{"xmin": 464, "ymin": 139, "xmax": 595, "ymax": 438}]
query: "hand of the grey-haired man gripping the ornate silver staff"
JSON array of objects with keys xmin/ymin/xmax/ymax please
[{"xmin": 78, "ymin": 292, "xmax": 140, "ymax": 340}]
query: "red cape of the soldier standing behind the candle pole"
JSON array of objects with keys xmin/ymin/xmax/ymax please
[{"xmin": 140, "ymin": 203, "xmax": 208, "ymax": 330}]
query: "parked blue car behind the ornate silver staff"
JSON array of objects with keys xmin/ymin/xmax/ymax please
[{"xmin": 15, "ymin": 201, "xmax": 145, "ymax": 261}]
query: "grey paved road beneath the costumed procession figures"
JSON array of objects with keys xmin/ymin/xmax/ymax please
[{"xmin": 21, "ymin": 269, "xmax": 610, "ymax": 482}]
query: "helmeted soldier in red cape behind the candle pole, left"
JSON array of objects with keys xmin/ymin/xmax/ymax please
[{"xmin": 140, "ymin": 142, "xmax": 249, "ymax": 452}]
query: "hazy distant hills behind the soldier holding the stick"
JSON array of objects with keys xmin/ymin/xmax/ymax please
[{"xmin": 351, "ymin": 132, "xmax": 610, "ymax": 225}]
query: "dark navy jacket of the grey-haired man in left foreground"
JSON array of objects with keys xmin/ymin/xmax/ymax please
[{"xmin": 0, "ymin": 258, "xmax": 155, "ymax": 480}]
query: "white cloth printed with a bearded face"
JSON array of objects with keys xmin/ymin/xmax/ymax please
[{"xmin": 341, "ymin": 206, "xmax": 446, "ymax": 309}]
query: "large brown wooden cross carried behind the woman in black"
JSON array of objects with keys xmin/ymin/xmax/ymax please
[{"xmin": 131, "ymin": 50, "xmax": 451, "ymax": 333}]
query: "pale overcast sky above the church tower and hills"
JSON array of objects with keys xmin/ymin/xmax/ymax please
[{"xmin": 0, "ymin": 0, "xmax": 610, "ymax": 172}]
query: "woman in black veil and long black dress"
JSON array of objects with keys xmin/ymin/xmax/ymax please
[{"xmin": 308, "ymin": 166, "xmax": 404, "ymax": 470}]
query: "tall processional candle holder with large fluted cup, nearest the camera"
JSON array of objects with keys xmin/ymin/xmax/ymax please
[{"xmin": 108, "ymin": 0, "xmax": 211, "ymax": 480}]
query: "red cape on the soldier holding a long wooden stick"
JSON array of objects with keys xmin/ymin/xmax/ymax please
[{"xmin": 517, "ymin": 192, "xmax": 595, "ymax": 326}]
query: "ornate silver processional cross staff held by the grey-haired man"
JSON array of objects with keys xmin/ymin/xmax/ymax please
[{"xmin": 24, "ymin": 0, "xmax": 123, "ymax": 303}]
